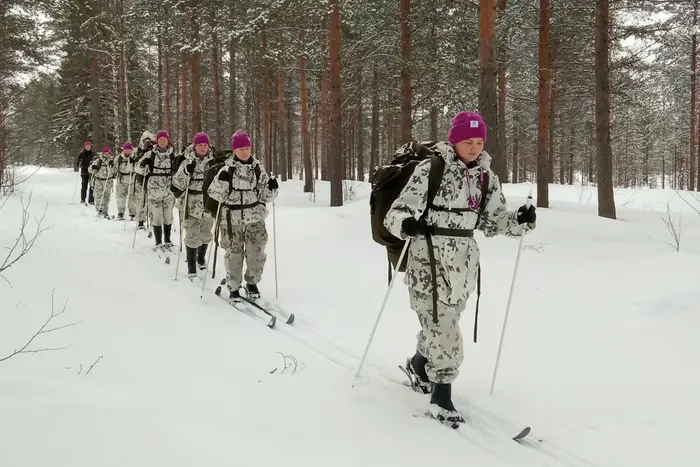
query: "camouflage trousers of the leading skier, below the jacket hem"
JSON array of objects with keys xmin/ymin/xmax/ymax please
[{"xmin": 408, "ymin": 288, "xmax": 467, "ymax": 384}]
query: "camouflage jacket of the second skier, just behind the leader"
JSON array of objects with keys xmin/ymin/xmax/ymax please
[{"xmin": 207, "ymin": 154, "xmax": 278, "ymax": 225}]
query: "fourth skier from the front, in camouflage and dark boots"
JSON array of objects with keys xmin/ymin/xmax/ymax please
[{"xmin": 139, "ymin": 130, "xmax": 175, "ymax": 250}]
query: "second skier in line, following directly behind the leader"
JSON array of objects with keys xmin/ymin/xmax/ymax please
[{"xmin": 207, "ymin": 130, "xmax": 279, "ymax": 301}]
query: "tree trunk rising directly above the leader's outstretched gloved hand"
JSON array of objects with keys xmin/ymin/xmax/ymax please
[{"xmin": 537, "ymin": 0, "xmax": 551, "ymax": 208}]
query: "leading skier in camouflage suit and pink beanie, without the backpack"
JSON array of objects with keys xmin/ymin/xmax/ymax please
[{"xmin": 384, "ymin": 112, "xmax": 536, "ymax": 425}]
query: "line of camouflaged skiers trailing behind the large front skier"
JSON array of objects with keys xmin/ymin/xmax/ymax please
[{"xmin": 75, "ymin": 130, "xmax": 279, "ymax": 301}]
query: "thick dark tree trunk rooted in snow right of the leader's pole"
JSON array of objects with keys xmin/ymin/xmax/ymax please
[{"xmin": 595, "ymin": 0, "xmax": 616, "ymax": 219}]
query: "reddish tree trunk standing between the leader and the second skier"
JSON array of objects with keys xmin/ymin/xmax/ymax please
[{"xmin": 328, "ymin": 0, "xmax": 343, "ymax": 206}]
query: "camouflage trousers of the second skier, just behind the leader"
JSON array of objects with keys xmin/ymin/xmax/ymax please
[{"xmin": 219, "ymin": 218, "xmax": 267, "ymax": 290}]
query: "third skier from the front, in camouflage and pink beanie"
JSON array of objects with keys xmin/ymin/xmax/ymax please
[{"xmin": 173, "ymin": 133, "xmax": 214, "ymax": 278}]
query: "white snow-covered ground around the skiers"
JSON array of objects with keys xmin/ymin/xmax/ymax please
[{"xmin": 0, "ymin": 169, "xmax": 700, "ymax": 467}]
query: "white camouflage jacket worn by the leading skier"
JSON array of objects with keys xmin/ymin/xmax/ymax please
[{"xmin": 384, "ymin": 142, "xmax": 525, "ymax": 307}]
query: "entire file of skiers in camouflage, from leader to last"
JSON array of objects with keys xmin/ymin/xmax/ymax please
[{"xmin": 76, "ymin": 112, "xmax": 536, "ymax": 427}]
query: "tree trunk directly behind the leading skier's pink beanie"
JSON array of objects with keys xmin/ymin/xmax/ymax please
[{"xmin": 476, "ymin": 0, "xmax": 508, "ymax": 180}]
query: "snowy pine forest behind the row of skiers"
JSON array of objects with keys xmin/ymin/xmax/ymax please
[{"xmin": 0, "ymin": 0, "xmax": 700, "ymax": 218}]
